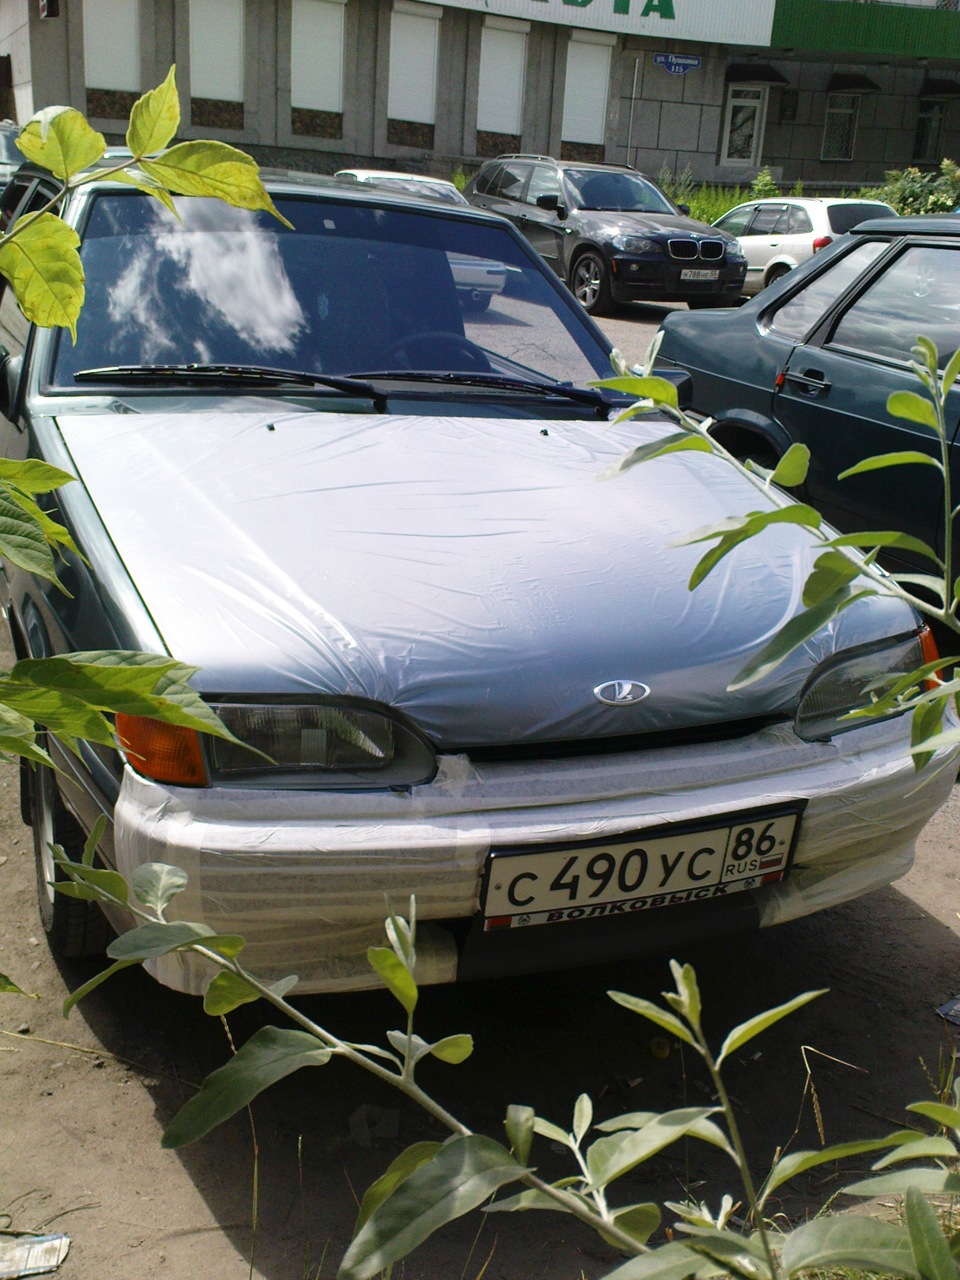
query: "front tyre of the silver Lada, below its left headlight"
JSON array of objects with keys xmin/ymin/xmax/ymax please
[{"xmin": 31, "ymin": 764, "xmax": 114, "ymax": 960}]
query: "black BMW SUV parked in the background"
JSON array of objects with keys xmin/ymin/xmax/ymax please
[{"xmin": 463, "ymin": 155, "xmax": 746, "ymax": 314}]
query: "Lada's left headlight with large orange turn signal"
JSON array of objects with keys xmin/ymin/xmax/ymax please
[{"xmin": 116, "ymin": 700, "xmax": 436, "ymax": 791}]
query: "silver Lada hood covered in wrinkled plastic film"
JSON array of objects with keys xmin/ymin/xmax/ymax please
[{"xmin": 58, "ymin": 401, "xmax": 915, "ymax": 749}]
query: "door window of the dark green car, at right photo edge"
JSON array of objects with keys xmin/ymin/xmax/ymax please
[{"xmin": 829, "ymin": 246, "xmax": 960, "ymax": 369}]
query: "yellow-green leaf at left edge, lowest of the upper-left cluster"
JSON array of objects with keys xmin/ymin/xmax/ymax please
[{"xmin": 0, "ymin": 214, "xmax": 83, "ymax": 342}]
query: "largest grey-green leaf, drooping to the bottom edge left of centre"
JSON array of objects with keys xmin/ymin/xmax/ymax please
[{"xmin": 338, "ymin": 1134, "xmax": 526, "ymax": 1280}]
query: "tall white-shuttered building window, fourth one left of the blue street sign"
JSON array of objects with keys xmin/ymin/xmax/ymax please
[{"xmin": 291, "ymin": 0, "xmax": 346, "ymax": 138}]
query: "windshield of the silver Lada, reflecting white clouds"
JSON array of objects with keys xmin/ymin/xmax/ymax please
[{"xmin": 51, "ymin": 192, "xmax": 611, "ymax": 388}]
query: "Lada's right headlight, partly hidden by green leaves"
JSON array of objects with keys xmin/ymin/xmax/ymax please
[{"xmin": 794, "ymin": 627, "xmax": 937, "ymax": 742}]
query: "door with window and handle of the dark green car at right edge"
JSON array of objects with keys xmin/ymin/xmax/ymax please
[{"xmin": 773, "ymin": 242, "xmax": 960, "ymax": 571}]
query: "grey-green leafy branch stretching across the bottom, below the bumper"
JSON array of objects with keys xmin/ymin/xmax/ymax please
[{"xmin": 47, "ymin": 849, "xmax": 960, "ymax": 1280}]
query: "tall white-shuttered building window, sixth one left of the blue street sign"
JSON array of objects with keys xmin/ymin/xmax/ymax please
[{"xmin": 83, "ymin": 0, "xmax": 141, "ymax": 120}]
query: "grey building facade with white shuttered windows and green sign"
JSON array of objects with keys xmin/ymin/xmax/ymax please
[{"xmin": 0, "ymin": 0, "xmax": 960, "ymax": 192}]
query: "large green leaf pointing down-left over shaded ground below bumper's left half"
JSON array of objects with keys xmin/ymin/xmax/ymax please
[{"xmin": 163, "ymin": 1027, "xmax": 330, "ymax": 1147}]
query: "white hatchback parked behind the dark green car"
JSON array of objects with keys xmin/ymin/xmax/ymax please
[{"xmin": 713, "ymin": 196, "xmax": 896, "ymax": 297}]
